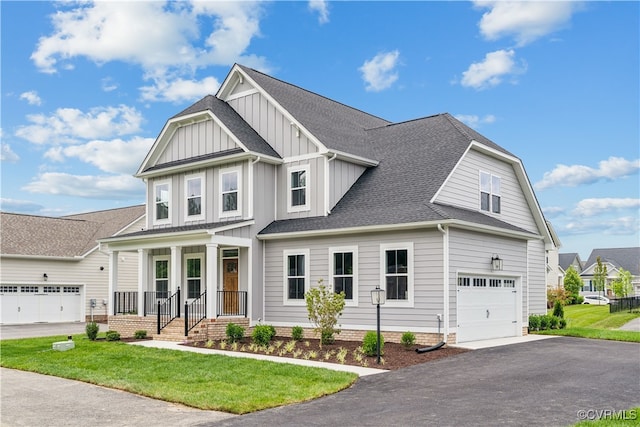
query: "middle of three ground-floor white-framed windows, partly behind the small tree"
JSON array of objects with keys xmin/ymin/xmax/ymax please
[{"xmin": 329, "ymin": 246, "xmax": 358, "ymax": 306}]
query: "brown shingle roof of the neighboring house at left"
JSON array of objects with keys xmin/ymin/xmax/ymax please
[{"xmin": 0, "ymin": 205, "xmax": 145, "ymax": 258}]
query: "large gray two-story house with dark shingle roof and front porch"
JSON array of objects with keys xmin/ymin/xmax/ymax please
[{"xmin": 100, "ymin": 64, "xmax": 555, "ymax": 343}]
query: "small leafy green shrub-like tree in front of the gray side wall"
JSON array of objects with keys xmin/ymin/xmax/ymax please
[{"xmin": 304, "ymin": 279, "xmax": 345, "ymax": 344}]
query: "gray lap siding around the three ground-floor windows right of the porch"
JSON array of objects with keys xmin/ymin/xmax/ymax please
[{"xmin": 264, "ymin": 229, "xmax": 444, "ymax": 333}]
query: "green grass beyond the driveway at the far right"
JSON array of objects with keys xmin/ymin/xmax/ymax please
[{"xmin": 535, "ymin": 304, "xmax": 640, "ymax": 342}]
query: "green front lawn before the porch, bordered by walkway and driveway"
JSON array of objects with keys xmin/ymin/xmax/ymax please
[{"xmin": 0, "ymin": 335, "xmax": 357, "ymax": 414}]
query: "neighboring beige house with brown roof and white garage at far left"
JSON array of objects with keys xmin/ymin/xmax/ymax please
[{"xmin": 0, "ymin": 206, "xmax": 146, "ymax": 324}]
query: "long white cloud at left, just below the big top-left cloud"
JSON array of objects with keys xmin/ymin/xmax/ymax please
[{"xmin": 16, "ymin": 105, "xmax": 142, "ymax": 144}]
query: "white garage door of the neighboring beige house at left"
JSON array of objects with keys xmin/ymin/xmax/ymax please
[{"xmin": 0, "ymin": 285, "xmax": 82, "ymax": 324}]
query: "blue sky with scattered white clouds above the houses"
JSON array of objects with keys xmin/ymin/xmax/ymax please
[{"xmin": 0, "ymin": 1, "xmax": 640, "ymax": 259}]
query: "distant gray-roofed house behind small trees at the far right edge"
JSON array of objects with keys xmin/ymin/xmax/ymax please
[{"xmin": 580, "ymin": 247, "xmax": 640, "ymax": 296}]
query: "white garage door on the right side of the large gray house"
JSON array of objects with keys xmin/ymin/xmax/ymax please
[{"xmin": 457, "ymin": 276, "xmax": 519, "ymax": 342}]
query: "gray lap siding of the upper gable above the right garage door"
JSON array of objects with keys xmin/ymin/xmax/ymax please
[{"xmin": 435, "ymin": 150, "xmax": 539, "ymax": 233}]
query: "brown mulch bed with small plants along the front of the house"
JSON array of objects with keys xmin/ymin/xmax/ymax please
[{"xmin": 182, "ymin": 337, "xmax": 468, "ymax": 370}]
